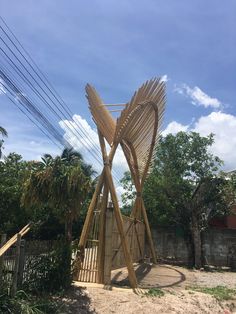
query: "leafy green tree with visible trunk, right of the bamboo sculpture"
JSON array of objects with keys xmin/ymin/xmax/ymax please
[{"xmin": 121, "ymin": 132, "xmax": 234, "ymax": 268}]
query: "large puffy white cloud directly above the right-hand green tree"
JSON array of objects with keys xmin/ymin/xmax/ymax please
[{"xmin": 162, "ymin": 111, "xmax": 236, "ymax": 171}]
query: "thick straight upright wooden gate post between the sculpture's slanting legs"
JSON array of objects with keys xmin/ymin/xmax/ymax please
[{"xmin": 104, "ymin": 207, "xmax": 113, "ymax": 285}]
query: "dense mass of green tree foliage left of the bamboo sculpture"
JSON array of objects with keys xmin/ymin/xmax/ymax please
[{"xmin": 0, "ymin": 149, "xmax": 95, "ymax": 240}]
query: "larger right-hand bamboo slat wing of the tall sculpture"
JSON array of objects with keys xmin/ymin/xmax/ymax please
[{"xmin": 115, "ymin": 79, "xmax": 165, "ymax": 182}]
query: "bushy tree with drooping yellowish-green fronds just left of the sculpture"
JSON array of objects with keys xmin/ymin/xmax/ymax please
[{"xmin": 22, "ymin": 150, "xmax": 92, "ymax": 242}]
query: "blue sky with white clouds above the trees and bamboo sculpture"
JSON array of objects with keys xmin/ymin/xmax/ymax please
[{"xmin": 0, "ymin": 0, "xmax": 236, "ymax": 174}]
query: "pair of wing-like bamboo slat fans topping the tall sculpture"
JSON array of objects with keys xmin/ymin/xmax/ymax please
[{"xmin": 86, "ymin": 78, "xmax": 165, "ymax": 182}]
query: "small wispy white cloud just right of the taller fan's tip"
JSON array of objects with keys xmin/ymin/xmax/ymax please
[{"xmin": 174, "ymin": 84, "xmax": 222, "ymax": 108}]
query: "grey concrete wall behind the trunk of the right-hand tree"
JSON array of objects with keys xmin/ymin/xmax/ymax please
[{"xmin": 152, "ymin": 228, "xmax": 236, "ymax": 268}]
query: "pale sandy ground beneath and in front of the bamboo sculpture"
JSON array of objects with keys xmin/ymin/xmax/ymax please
[{"xmin": 63, "ymin": 265, "xmax": 236, "ymax": 314}]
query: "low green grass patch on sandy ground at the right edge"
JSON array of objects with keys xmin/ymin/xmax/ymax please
[{"xmin": 186, "ymin": 286, "xmax": 236, "ymax": 301}]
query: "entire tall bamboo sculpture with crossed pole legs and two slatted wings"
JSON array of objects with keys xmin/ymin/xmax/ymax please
[{"xmin": 76, "ymin": 78, "xmax": 165, "ymax": 288}]
